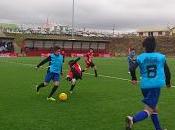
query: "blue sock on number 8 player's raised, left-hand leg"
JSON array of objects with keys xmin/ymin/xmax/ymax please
[{"xmin": 133, "ymin": 111, "xmax": 149, "ymax": 123}]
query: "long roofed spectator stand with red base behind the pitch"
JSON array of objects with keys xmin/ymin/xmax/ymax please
[{"xmin": 22, "ymin": 39, "xmax": 109, "ymax": 56}]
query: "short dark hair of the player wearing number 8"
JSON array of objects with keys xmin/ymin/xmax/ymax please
[{"xmin": 142, "ymin": 36, "xmax": 156, "ymax": 52}]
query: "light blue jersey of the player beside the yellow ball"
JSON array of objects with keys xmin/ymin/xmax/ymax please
[{"xmin": 49, "ymin": 54, "xmax": 63, "ymax": 74}]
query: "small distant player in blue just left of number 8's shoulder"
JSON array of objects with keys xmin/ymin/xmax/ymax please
[{"xmin": 128, "ymin": 48, "xmax": 136, "ymax": 74}]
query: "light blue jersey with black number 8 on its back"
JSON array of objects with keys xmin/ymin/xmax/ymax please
[{"xmin": 137, "ymin": 52, "xmax": 166, "ymax": 89}]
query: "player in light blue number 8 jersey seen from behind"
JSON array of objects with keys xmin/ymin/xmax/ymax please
[{"xmin": 126, "ymin": 36, "xmax": 171, "ymax": 130}]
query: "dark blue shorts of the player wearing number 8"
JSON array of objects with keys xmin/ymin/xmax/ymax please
[{"xmin": 142, "ymin": 88, "xmax": 160, "ymax": 109}]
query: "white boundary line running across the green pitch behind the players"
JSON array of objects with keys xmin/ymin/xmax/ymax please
[{"xmin": 3, "ymin": 61, "xmax": 175, "ymax": 88}]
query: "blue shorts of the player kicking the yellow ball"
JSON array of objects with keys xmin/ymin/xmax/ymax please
[{"xmin": 45, "ymin": 72, "xmax": 60, "ymax": 83}]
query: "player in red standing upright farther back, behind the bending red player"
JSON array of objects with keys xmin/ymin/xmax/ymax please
[{"xmin": 83, "ymin": 48, "xmax": 97, "ymax": 77}]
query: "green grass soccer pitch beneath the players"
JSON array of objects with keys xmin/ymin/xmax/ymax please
[{"xmin": 0, "ymin": 58, "xmax": 175, "ymax": 130}]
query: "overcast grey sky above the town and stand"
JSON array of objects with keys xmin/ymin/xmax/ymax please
[{"xmin": 0, "ymin": 0, "xmax": 175, "ymax": 30}]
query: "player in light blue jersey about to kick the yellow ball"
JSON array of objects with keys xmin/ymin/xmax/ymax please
[{"xmin": 36, "ymin": 47, "xmax": 63, "ymax": 101}]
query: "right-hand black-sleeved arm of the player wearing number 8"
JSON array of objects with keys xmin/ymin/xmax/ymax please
[{"xmin": 164, "ymin": 62, "xmax": 171, "ymax": 88}]
